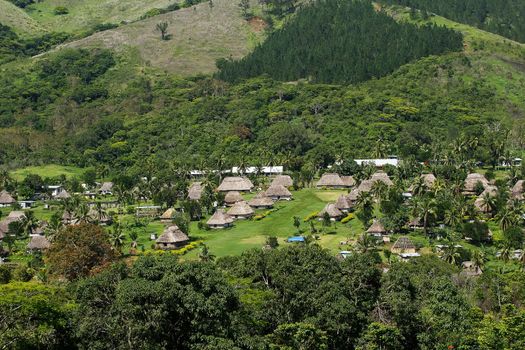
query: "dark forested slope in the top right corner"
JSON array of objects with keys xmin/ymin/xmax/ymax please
[{"xmin": 381, "ymin": 0, "xmax": 525, "ymax": 43}]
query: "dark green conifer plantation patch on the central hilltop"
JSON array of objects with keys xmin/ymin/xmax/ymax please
[{"xmin": 218, "ymin": 0, "xmax": 463, "ymax": 83}]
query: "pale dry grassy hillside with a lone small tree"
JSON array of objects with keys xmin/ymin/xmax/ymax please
[{"xmin": 60, "ymin": 0, "xmax": 262, "ymax": 76}]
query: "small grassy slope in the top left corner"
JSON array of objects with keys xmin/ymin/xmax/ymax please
[{"xmin": 0, "ymin": 0, "xmax": 45, "ymax": 36}]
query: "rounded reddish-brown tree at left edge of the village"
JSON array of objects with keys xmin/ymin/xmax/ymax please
[{"xmin": 44, "ymin": 223, "xmax": 116, "ymax": 281}]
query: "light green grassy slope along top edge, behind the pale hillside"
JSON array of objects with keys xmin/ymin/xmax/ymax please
[{"xmin": 26, "ymin": 0, "xmax": 177, "ymax": 33}]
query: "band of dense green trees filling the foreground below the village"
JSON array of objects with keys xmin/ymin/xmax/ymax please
[{"xmin": 0, "ymin": 242, "xmax": 525, "ymax": 350}]
